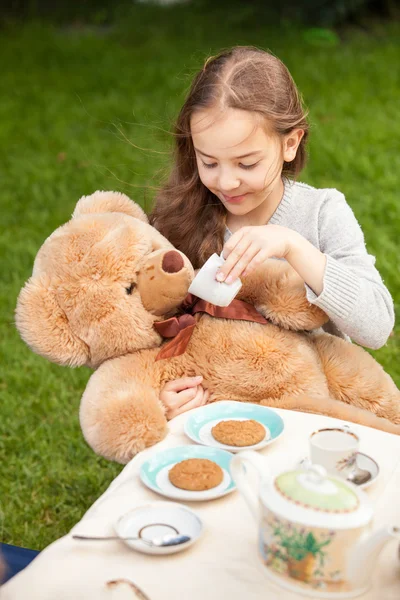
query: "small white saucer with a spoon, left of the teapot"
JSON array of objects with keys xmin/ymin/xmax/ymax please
[{"xmin": 115, "ymin": 502, "xmax": 203, "ymax": 554}]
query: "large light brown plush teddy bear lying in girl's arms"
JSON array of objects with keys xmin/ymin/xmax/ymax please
[{"xmin": 16, "ymin": 192, "xmax": 400, "ymax": 463}]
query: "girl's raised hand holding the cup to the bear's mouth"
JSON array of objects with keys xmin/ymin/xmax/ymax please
[{"xmin": 216, "ymin": 225, "xmax": 296, "ymax": 284}]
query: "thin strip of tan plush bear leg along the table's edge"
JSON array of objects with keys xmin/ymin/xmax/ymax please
[{"xmin": 260, "ymin": 394, "xmax": 400, "ymax": 435}]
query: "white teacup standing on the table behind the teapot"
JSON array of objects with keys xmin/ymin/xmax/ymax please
[{"xmin": 310, "ymin": 425, "xmax": 360, "ymax": 478}]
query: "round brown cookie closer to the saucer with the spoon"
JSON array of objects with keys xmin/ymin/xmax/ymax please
[{"xmin": 168, "ymin": 458, "xmax": 224, "ymax": 492}]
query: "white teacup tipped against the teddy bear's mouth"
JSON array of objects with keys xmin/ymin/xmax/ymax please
[{"xmin": 189, "ymin": 254, "xmax": 242, "ymax": 306}]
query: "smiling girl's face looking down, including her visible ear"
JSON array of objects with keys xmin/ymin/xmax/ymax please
[{"xmin": 190, "ymin": 108, "xmax": 303, "ymax": 216}]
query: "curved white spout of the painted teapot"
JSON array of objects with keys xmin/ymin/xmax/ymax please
[{"xmin": 348, "ymin": 525, "xmax": 400, "ymax": 588}]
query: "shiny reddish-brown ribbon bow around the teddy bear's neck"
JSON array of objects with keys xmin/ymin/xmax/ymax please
[{"xmin": 154, "ymin": 294, "xmax": 268, "ymax": 360}]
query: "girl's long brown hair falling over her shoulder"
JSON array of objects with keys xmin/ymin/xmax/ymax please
[{"xmin": 150, "ymin": 46, "xmax": 308, "ymax": 268}]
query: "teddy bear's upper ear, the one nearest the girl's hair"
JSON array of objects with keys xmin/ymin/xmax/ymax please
[{"xmin": 72, "ymin": 191, "xmax": 149, "ymax": 223}]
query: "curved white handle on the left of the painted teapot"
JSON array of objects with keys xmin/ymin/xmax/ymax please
[{"xmin": 230, "ymin": 450, "xmax": 269, "ymax": 523}]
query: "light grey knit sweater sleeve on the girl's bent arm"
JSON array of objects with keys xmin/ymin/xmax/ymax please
[{"xmin": 306, "ymin": 190, "xmax": 394, "ymax": 350}]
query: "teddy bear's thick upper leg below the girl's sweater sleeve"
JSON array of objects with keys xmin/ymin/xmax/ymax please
[{"xmin": 313, "ymin": 334, "xmax": 400, "ymax": 424}]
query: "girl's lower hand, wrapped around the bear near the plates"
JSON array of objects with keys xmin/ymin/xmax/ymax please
[{"xmin": 160, "ymin": 375, "xmax": 210, "ymax": 421}]
